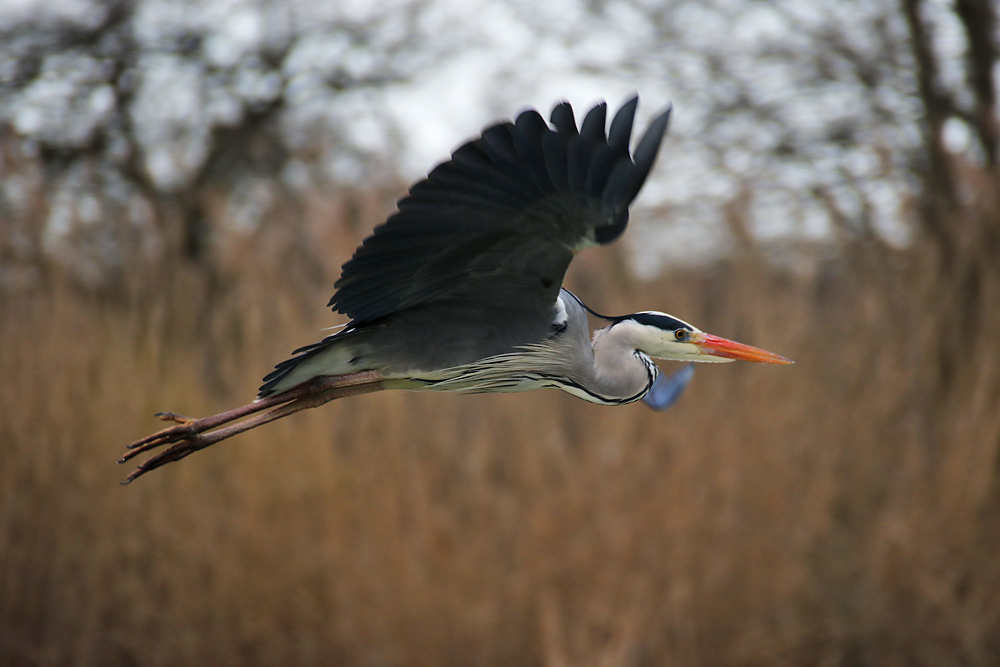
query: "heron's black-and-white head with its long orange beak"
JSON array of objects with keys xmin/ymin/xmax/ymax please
[{"xmin": 609, "ymin": 311, "xmax": 793, "ymax": 364}]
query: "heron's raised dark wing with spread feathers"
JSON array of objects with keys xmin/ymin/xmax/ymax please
[{"xmin": 329, "ymin": 97, "xmax": 670, "ymax": 323}]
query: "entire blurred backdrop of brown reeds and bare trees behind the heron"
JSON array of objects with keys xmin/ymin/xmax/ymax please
[{"xmin": 0, "ymin": 0, "xmax": 1000, "ymax": 665}]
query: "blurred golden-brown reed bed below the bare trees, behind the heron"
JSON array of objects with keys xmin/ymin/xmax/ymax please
[{"xmin": 0, "ymin": 211, "xmax": 1000, "ymax": 665}]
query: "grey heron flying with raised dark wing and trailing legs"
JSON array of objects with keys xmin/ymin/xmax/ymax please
[{"xmin": 120, "ymin": 97, "xmax": 791, "ymax": 483}]
